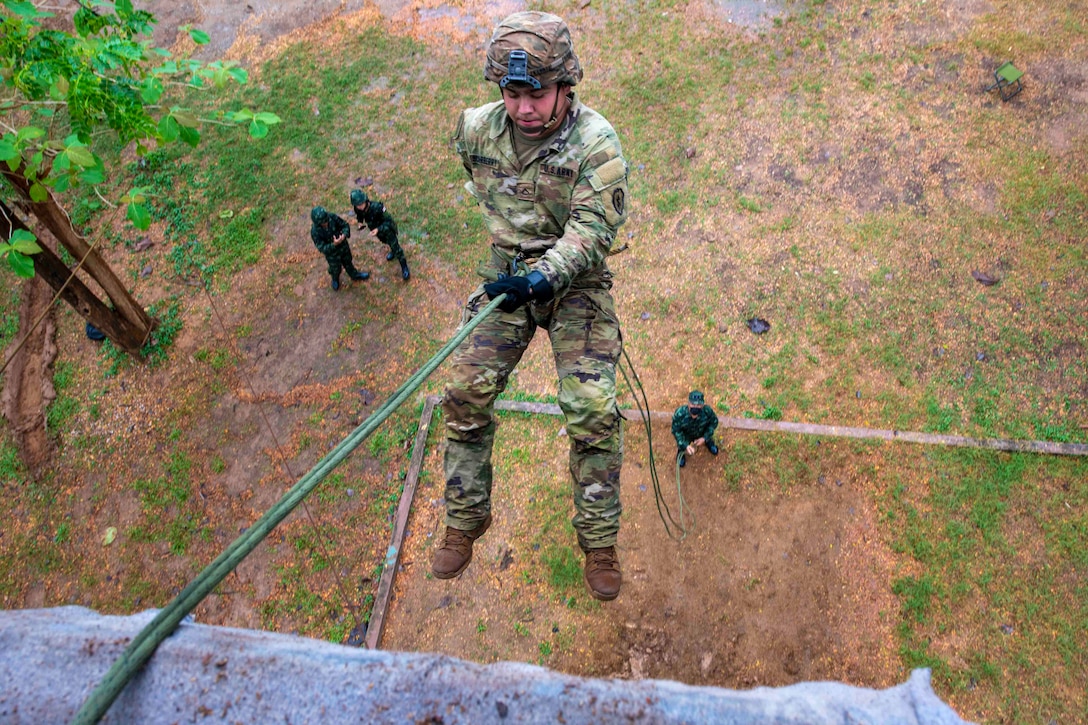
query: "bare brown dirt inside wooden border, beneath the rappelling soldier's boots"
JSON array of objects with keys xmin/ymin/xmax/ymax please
[{"xmin": 382, "ymin": 414, "xmax": 901, "ymax": 688}]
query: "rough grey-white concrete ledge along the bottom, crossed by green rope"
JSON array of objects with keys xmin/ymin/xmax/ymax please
[{"xmin": 0, "ymin": 606, "xmax": 964, "ymax": 725}]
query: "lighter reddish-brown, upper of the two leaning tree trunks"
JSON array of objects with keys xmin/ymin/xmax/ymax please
[{"xmin": 0, "ymin": 165, "xmax": 154, "ymax": 354}]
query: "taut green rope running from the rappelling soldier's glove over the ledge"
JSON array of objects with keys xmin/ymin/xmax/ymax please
[{"xmin": 72, "ymin": 294, "xmax": 506, "ymax": 725}]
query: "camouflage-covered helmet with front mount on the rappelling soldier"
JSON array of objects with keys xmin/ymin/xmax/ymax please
[{"xmin": 483, "ymin": 10, "xmax": 582, "ymax": 88}]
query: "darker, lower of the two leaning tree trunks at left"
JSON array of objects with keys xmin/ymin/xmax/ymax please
[{"xmin": 0, "ymin": 201, "xmax": 145, "ymax": 354}]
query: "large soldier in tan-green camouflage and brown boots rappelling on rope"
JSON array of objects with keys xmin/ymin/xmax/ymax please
[{"xmin": 432, "ymin": 12, "xmax": 627, "ymax": 600}]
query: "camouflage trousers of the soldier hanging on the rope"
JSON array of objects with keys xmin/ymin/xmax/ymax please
[{"xmin": 442, "ymin": 279, "xmax": 623, "ymax": 549}]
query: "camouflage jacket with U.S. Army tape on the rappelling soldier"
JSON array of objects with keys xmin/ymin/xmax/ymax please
[{"xmin": 454, "ymin": 94, "xmax": 627, "ymax": 298}]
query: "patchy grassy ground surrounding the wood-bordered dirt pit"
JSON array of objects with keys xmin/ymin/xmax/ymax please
[{"xmin": 0, "ymin": 1, "xmax": 1088, "ymax": 722}]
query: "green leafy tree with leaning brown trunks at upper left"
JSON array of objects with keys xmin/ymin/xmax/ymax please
[{"xmin": 0, "ymin": 0, "xmax": 280, "ymax": 353}]
